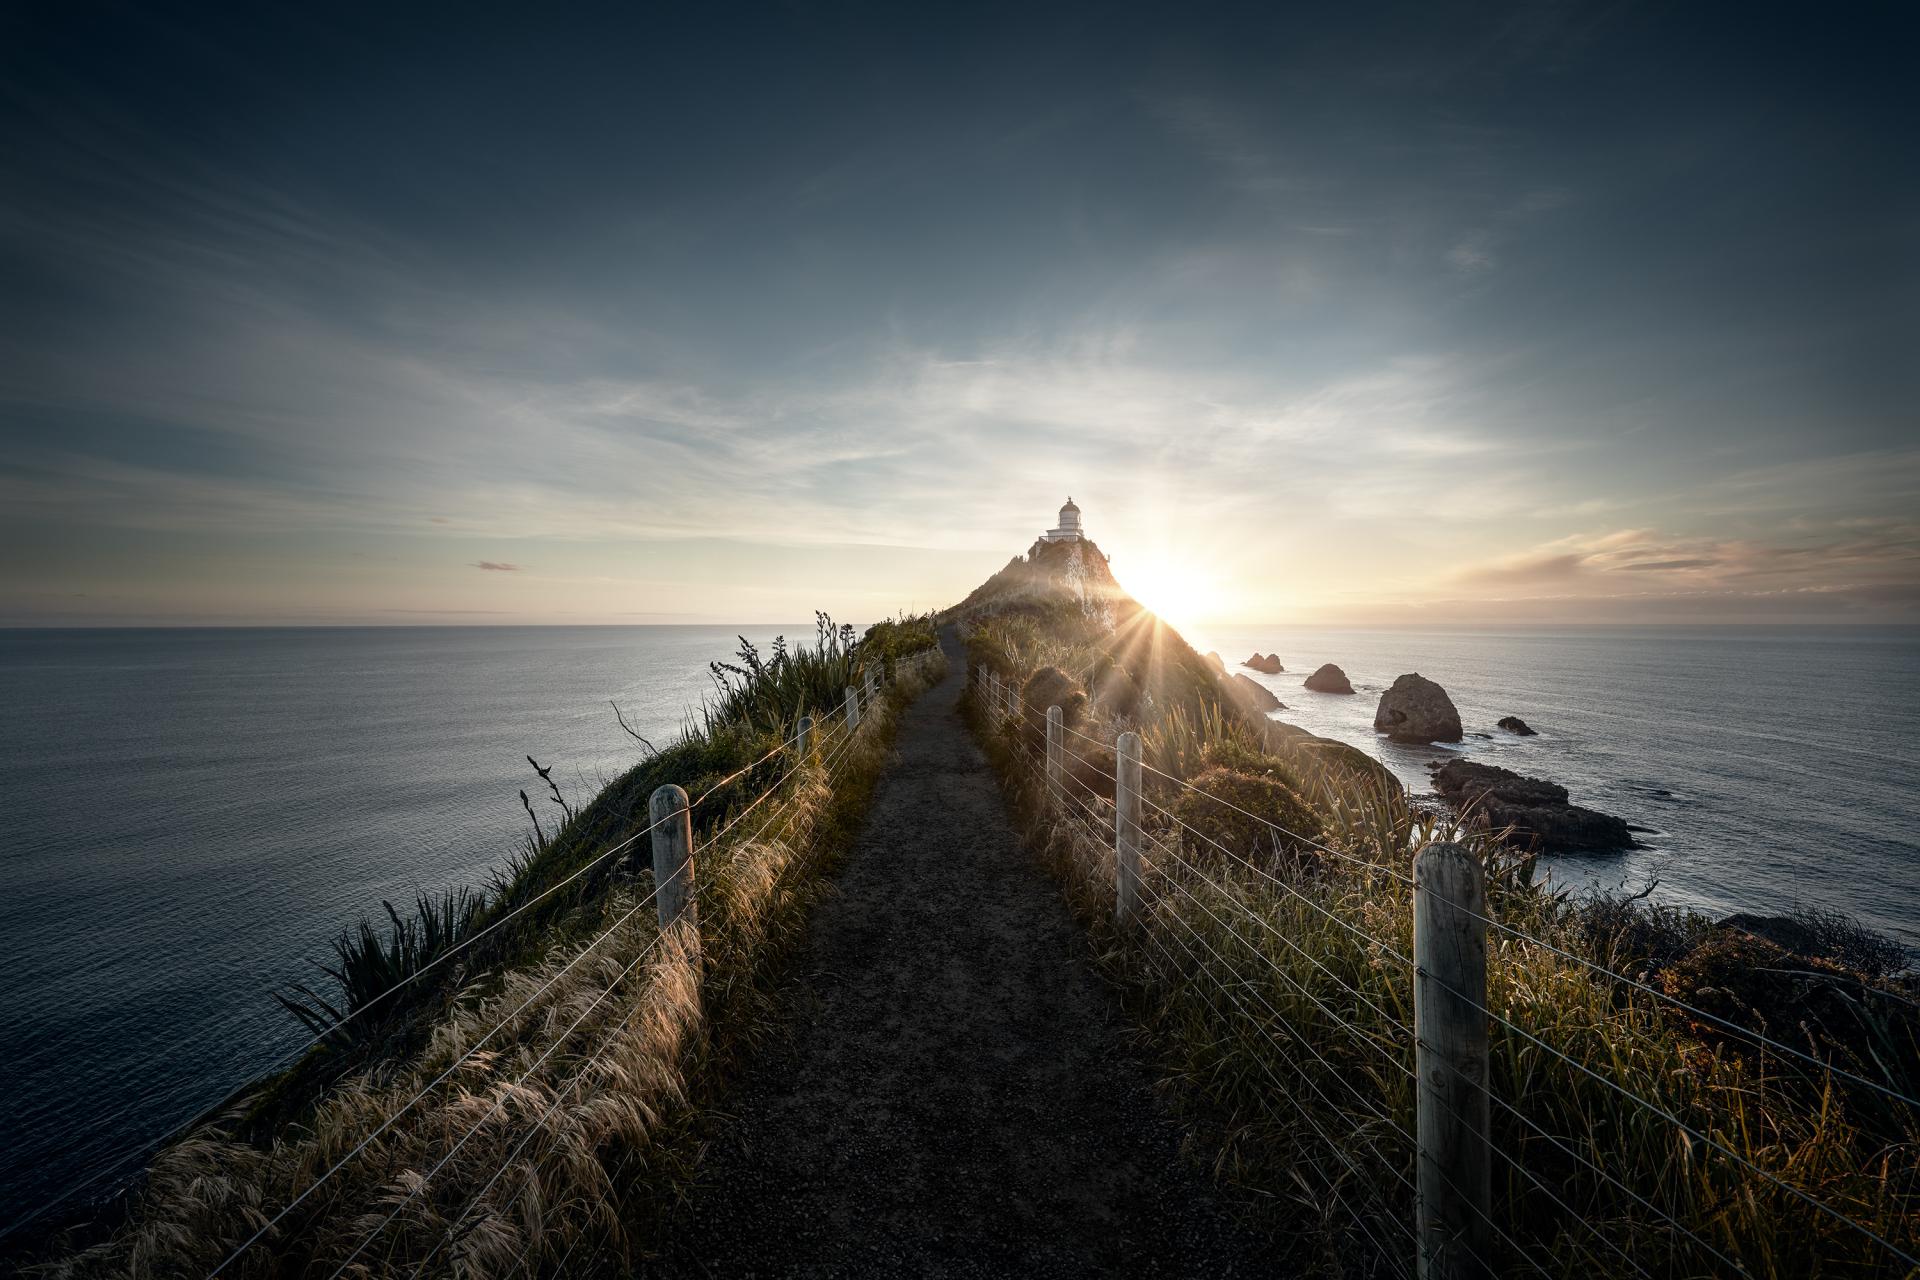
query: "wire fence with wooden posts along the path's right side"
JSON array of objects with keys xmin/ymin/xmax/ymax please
[{"xmin": 970, "ymin": 668, "xmax": 1920, "ymax": 1276}]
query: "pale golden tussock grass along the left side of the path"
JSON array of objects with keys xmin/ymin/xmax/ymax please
[{"xmin": 36, "ymin": 637, "xmax": 945, "ymax": 1278}]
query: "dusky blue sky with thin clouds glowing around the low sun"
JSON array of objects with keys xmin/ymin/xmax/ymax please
[{"xmin": 0, "ymin": 0, "xmax": 1920, "ymax": 626}]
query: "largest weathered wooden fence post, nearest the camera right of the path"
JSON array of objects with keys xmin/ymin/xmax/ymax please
[{"xmin": 1413, "ymin": 844, "xmax": 1494, "ymax": 1280}]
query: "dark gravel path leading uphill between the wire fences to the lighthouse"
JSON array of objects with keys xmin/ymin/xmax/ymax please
[{"xmin": 659, "ymin": 637, "xmax": 1275, "ymax": 1278}]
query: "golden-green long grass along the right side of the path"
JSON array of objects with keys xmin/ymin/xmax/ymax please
[{"xmin": 975, "ymin": 652, "xmax": 1920, "ymax": 1280}]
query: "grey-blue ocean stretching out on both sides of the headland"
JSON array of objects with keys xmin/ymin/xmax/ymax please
[{"xmin": 0, "ymin": 622, "xmax": 1920, "ymax": 1226}]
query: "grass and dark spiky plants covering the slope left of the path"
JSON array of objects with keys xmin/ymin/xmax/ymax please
[{"xmin": 33, "ymin": 616, "xmax": 943, "ymax": 1276}]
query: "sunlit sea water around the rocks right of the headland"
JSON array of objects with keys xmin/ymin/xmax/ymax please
[{"xmin": 1188, "ymin": 628, "xmax": 1920, "ymax": 948}]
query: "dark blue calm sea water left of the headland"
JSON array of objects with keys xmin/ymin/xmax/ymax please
[{"xmin": 0, "ymin": 622, "xmax": 814, "ymax": 1226}]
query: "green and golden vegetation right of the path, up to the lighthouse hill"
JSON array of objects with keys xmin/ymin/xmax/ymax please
[{"xmin": 952, "ymin": 553, "xmax": 1920, "ymax": 1280}]
